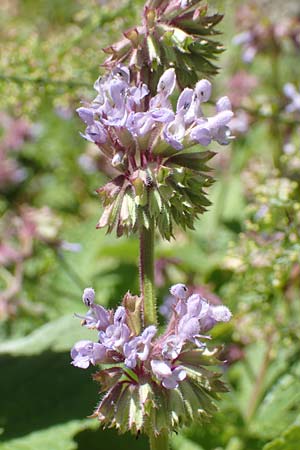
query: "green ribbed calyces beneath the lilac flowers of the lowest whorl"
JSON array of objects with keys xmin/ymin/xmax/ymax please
[{"xmin": 93, "ymin": 349, "xmax": 227, "ymax": 436}]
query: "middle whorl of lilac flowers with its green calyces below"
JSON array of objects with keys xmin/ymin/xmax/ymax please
[{"xmin": 77, "ymin": 65, "xmax": 233, "ymax": 239}]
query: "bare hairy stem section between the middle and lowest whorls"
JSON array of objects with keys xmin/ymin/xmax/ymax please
[{"xmin": 140, "ymin": 220, "xmax": 157, "ymax": 327}]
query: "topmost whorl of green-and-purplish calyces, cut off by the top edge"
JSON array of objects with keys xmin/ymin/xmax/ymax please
[{"xmin": 104, "ymin": 0, "xmax": 223, "ymax": 90}]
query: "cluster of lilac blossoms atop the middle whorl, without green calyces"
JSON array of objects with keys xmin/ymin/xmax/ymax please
[{"xmin": 77, "ymin": 65, "xmax": 233, "ymax": 166}]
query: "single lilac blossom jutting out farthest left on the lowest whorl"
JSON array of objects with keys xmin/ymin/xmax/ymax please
[{"xmin": 71, "ymin": 341, "xmax": 106, "ymax": 369}]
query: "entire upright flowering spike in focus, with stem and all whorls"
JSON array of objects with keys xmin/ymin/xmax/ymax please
[{"xmin": 71, "ymin": 1, "xmax": 233, "ymax": 450}]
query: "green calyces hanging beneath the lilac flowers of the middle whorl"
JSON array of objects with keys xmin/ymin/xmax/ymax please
[{"xmin": 97, "ymin": 151, "xmax": 214, "ymax": 239}]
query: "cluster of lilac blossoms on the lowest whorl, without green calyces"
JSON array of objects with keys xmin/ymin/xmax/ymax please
[{"xmin": 71, "ymin": 283, "xmax": 231, "ymax": 396}]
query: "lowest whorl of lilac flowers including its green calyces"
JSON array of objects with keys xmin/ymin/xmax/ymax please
[{"xmin": 71, "ymin": 284, "xmax": 231, "ymax": 435}]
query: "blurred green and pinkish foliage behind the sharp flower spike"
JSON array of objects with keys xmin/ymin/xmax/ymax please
[{"xmin": 0, "ymin": 0, "xmax": 300, "ymax": 450}]
